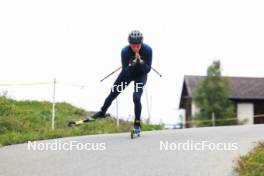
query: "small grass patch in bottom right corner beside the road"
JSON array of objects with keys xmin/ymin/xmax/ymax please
[{"xmin": 234, "ymin": 142, "xmax": 264, "ymax": 176}]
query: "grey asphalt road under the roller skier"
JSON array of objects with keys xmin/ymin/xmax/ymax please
[{"xmin": 0, "ymin": 125, "xmax": 264, "ymax": 176}]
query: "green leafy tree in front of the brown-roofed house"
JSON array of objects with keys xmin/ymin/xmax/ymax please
[{"xmin": 193, "ymin": 61, "xmax": 236, "ymax": 126}]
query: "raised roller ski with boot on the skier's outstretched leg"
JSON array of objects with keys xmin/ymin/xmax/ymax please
[{"xmin": 67, "ymin": 111, "xmax": 110, "ymax": 127}]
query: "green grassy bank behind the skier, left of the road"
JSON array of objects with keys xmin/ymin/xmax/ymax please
[{"xmin": 0, "ymin": 96, "xmax": 162, "ymax": 146}]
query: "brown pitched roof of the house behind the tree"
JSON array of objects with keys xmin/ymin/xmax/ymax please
[{"xmin": 184, "ymin": 75, "xmax": 264, "ymax": 99}]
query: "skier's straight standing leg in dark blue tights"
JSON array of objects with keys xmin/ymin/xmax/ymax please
[{"xmin": 133, "ymin": 75, "xmax": 147, "ymax": 126}]
